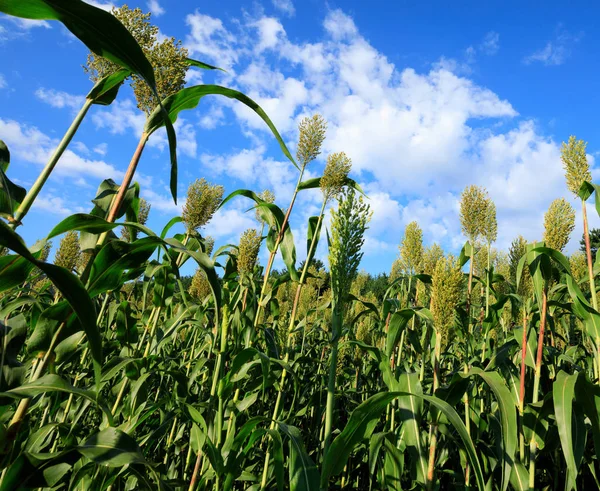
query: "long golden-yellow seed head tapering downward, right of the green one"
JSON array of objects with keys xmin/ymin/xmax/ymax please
[{"xmin": 431, "ymin": 255, "xmax": 464, "ymax": 349}]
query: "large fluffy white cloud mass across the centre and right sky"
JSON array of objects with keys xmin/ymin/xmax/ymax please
[{"xmin": 179, "ymin": 10, "xmax": 592, "ymax": 264}]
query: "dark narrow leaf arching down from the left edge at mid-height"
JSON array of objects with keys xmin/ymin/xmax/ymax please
[{"xmin": 0, "ymin": 222, "xmax": 102, "ymax": 380}]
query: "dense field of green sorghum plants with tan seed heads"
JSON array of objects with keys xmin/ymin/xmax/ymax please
[{"xmin": 0, "ymin": 0, "xmax": 600, "ymax": 490}]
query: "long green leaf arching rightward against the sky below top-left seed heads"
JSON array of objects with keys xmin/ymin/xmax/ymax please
[{"xmin": 145, "ymin": 85, "xmax": 298, "ymax": 168}]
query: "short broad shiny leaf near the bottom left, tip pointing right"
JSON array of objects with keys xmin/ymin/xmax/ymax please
[{"xmin": 77, "ymin": 427, "xmax": 146, "ymax": 467}]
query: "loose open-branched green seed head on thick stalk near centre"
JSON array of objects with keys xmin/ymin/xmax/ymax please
[{"xmin": 329, "ymin": 189, "xmax": 372, "ymax": 305}]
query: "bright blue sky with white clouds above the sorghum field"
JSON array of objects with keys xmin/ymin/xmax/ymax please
[{"xmin": 0, "ymin": 0, "xmax": 600, "ymax": 272}]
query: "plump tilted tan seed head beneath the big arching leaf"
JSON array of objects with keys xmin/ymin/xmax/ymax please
[{"xmin": 182, "ymin": 178, "xmax": 224, "ymax": 231}]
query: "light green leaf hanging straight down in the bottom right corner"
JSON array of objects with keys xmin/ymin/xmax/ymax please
[{"xmin": 552, "ymin": 370, "xmax": 581, "ymax": 491}]
